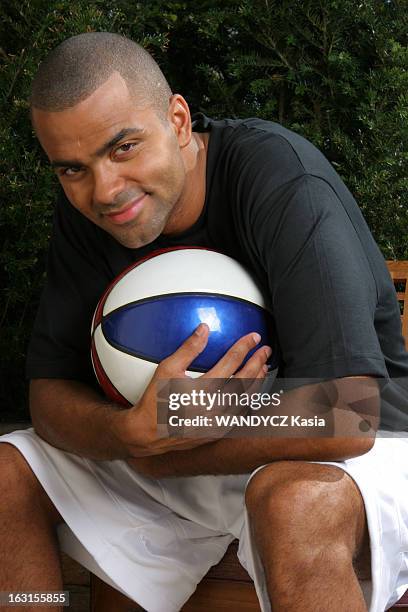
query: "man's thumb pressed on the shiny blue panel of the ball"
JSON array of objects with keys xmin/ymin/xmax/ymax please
[{"xmin": 156, "ymin": 323, "xmax": 209, "ymax": 378}]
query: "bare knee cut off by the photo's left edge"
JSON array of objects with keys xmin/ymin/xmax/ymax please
[{"xmin": 0, "ymin": 442, "xmax": 62, "ymax": 525}]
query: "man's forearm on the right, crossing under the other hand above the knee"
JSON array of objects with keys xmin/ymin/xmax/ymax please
[{"xmin": 128, "ymin": 377, "xmax": 380, "ymax": 478}]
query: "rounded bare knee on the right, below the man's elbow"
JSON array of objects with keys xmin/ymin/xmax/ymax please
[{"xmin": 246, "ymin": 461, "xmax": 365, "ymax": 555}]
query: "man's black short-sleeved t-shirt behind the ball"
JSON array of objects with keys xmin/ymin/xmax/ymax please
[{"xmin": 27, "ymin": 114, "xmax": 408, "ymax": 429}]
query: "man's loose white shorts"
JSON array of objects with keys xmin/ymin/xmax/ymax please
[{"xmin": 0, "ymin": 429, "xmax": 408, "ymax": 612}]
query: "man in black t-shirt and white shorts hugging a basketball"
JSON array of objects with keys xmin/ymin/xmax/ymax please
[{"xmin": 0, "ymin": 33, "xmax": 408, "ymax": 612}]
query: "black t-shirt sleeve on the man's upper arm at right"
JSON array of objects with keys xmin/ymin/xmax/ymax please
[{"xmin": 253, "ymin": 174, "xmax": 386, "ymax": 379}]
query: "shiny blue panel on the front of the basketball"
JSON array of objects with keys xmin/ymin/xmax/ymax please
[{"xmin": 102, "ymin": 294, "xmax": 278, "ymax": 372}]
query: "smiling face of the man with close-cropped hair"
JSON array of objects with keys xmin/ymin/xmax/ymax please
[{"xmin": 33, "ymin": 73, "xmax": 186, "ymax": 248}]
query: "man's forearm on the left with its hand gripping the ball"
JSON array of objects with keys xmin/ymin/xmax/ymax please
[{"xmin": 30, "ymin": 324, "xmax": 270, "ymax": 460}]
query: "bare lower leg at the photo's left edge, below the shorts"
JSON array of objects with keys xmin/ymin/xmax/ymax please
[{"xmin": 0, "ymin": 443, "xmax": 62, "ymax": 612}]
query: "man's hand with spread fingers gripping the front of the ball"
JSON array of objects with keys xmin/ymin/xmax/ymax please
[{"xmin": 117, "ymin": 323, "xmax": 271, "ymax": 460}]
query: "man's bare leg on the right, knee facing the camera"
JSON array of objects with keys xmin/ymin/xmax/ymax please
[{"xmin": 246, "ymin": 461, "xmax": 370, "ymax": 612}]
